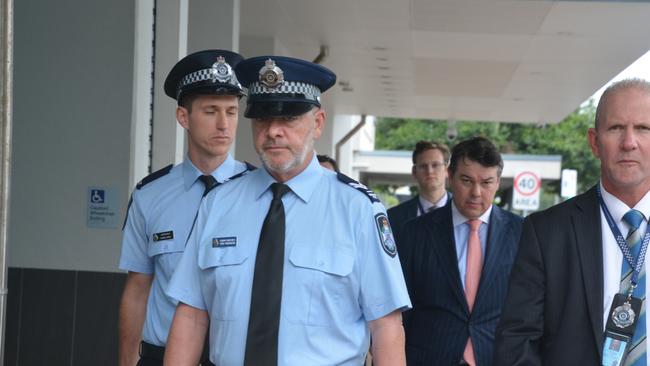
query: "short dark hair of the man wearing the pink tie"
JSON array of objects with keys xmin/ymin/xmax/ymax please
[{"xmin": 449, "ymin": 136, "xmax": 503, "ymax": 177}]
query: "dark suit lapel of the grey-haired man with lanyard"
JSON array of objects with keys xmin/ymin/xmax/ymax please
[{"xmin": 571, "ymin": 188, "xmax": 604, "ymax": 357}]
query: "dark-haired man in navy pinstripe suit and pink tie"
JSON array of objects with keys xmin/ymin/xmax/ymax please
[{"xmin": 398, "ymin": 137, "xmax": 522, "ymax": 366}]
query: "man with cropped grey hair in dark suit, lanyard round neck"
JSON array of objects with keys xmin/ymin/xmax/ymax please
[{"xmin": 495, "ymin": 79, "xmax": 650, "ymax": 366}]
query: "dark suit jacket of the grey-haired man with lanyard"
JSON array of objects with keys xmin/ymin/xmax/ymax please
[{"xmin": 495, "ymin": 188, "xmax": 603, "ymax": 366}]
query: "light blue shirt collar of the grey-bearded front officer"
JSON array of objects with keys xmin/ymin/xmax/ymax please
[{"xmin": 254, "ymin": 153, "xmax": 323, "ymax": 202}]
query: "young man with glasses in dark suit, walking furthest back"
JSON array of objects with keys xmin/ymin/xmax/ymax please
[{"xmin": 388, "ymin": 141, "xmax": 449, "ymax": 245}]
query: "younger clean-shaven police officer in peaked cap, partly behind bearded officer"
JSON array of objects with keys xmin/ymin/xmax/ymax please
[{"xmin": 119, "ymin": 50, "xmax": 248, "ymax": 366}]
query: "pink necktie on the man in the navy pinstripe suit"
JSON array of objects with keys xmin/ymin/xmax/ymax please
[{"xmin": 463, "ymin": 220, "xmax": 483, "ymax": 366}]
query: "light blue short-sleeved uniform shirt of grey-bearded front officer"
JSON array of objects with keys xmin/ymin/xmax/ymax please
[{"xmin": 167, "ymin": 155, "xmax": 411, "ymax": 366}]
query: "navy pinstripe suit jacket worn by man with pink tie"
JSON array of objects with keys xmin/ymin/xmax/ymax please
[{"xmin": 397, "ymin": 204, "xmax": 522, "ymax": 366}]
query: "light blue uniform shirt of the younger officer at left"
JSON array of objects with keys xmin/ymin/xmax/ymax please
[{"xmin": 119, "ymin": 156, "xmax": 246, "ymax": 346}]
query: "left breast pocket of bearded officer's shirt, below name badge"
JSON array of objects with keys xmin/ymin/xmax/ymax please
[{"xmin": 198, "ymin": 245, "xmax": 250, "ymax": 320}]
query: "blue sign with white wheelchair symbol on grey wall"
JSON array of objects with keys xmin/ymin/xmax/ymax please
[{"xmin": 86, "ymin": 187, "xmax": 120, "ymax": 229}]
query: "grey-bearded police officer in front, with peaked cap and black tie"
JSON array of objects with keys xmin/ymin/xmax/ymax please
[{"xmin": 165, "ymin": 56, "xmax": 410, "ymax": 366}]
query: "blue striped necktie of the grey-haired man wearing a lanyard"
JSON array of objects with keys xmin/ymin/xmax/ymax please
[{"xmin": 620, "ymin": 210, "xmax": 647, "ymax": 366}]
